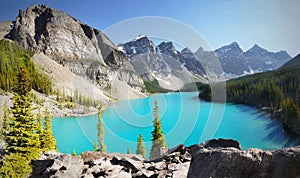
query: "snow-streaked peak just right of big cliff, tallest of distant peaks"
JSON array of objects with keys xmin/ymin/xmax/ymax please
[{"xmin": 118, "ymin": 35, "xmax": 205, "ymax": 90}]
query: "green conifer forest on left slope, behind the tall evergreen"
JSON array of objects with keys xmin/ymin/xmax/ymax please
[{"xmin": 0, "ymin": 40, "xmax": 52, "ymax": 94}]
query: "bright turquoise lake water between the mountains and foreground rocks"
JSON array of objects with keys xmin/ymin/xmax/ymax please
[{"xmin": 52, "ymin": 92, "xmax": 299, "ymax": 153}]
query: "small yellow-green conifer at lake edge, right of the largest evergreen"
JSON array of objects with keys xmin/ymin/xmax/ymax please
[{"xmin": 45, "ymin": 109, "xmax": 57, "ymax": 151}]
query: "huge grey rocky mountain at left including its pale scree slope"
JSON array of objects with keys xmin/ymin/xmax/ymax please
[{"xmin": 2, "ymin": 5, "xmax": 145, "ymax": 100}]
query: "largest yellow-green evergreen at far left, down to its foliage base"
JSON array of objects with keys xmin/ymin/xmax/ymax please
[{"xmin": 0, "ymin": 68, "xmax": 40, "ymax": 177}]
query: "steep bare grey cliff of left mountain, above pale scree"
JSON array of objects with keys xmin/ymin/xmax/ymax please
[{"xmin": 7, "ymin": 5, "xmax": 144, "ymax": 95}]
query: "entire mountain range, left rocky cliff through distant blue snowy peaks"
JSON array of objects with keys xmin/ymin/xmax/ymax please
[{"xmin": 1, "ymin": 5, "xmax": 291, "ymax": 96}]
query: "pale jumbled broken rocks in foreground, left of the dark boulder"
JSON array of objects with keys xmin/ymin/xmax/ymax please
[{"xmin": 31, "ymin": 146, "xmax": 191, "ymax": 178}]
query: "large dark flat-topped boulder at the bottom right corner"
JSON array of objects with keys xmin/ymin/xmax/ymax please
[{"xmin": 188, "ymin": 140, "xmax": 300, "ymax": 177}]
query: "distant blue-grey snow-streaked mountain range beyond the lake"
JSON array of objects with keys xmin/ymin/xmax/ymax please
[{"xmin": 118, "ymin": 35, "xmax": 291, "ymax": 85}]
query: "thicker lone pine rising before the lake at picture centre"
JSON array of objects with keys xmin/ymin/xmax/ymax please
[{"xmin": 150, "ymin": 100, "xmax": 167, "ymax": 159}]
